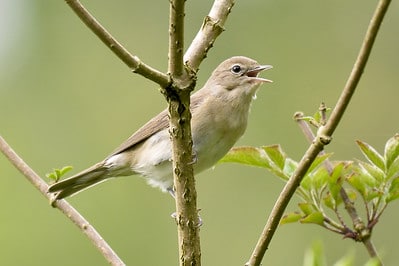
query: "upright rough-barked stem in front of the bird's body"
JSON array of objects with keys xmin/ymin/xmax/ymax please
[{"xmin": 164, "ymin": 0, "xmax": 201, "ymax": 266}]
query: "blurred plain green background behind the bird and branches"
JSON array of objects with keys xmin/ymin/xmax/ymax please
[{"xmin": 0, "ymin": 0, "xmax": 399, "ymax": 265}]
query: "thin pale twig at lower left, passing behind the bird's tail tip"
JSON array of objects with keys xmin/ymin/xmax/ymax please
[{"xmin": 0, "ymin": 136, "xmax": 125, "ymax": 265}]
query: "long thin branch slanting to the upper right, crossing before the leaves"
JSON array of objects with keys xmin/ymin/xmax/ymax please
[{"xmin": 246, "ymin": 0, "xmax": 391, "ymax": 266}]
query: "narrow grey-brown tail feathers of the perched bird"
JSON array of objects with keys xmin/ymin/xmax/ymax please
[{"xmin": 48, "ymin": 162, "xmax": 110, "ymax": 200}]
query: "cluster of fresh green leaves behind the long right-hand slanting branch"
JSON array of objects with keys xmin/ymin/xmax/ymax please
[{"xmin": 221, "ymin": 134, "xmax": 399, "ymax": 240}]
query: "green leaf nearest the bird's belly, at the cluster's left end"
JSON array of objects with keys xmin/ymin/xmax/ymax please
[{"xmin": 219, "ymin": 146, "xmax": 271, "ymax": 169}]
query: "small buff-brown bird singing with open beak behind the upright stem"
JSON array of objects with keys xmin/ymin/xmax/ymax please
[{"xmin": 48, "ymin": 56, "xmax": 272, "ymax": 202}]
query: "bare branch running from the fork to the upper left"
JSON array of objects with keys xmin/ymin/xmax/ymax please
[{"xmin": 65, "ymin": 0, "xmax": 170, "ymax": 87}]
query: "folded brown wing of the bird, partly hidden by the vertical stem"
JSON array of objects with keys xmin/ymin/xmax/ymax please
[{"xmin": 108, "ymin": 93, "xmax": 203, "ymax": 158}]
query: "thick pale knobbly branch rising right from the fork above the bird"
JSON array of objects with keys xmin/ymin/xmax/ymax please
[{"xmin": 184, "ymin": 0, "xmax": 234, "ymax": 71}]
